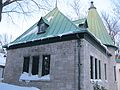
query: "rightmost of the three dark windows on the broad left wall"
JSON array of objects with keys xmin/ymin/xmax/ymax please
[{"xmin": 42, "ymin": 55, "xmax": 50, "ymax": 76}]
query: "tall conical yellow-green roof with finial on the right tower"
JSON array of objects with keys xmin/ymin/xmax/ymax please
[{"xmin": 87, "ymin": 2, "xmax": 114, "ymax": 46}]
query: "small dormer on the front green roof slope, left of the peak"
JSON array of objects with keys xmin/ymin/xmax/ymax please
[{"xmin": 37, "ymin": 17, "xmax": 49, "ymax": 34}]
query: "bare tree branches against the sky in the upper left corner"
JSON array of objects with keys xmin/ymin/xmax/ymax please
[{"xmin": 0, "ymin": 0, "xmax": 52, "ymax": 21}]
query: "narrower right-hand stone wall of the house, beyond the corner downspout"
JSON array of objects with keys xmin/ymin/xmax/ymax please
[{"xmin": 81, "ymin": 40, "xmax": 117, "ymax": 90}]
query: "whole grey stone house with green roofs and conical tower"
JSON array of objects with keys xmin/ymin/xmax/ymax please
[{"xmin": 4, "ymin": 2, "xmax": 117, "ymax": 90}]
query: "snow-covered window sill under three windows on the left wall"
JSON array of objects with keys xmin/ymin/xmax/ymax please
[{"xmin": 19, "ymin": 72, "xmax": 50, "ymax": 82}]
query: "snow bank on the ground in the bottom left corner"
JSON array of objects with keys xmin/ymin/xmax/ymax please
[{"xmin": 0, "ymin": 83, "xmax": 40, "ymax": 90}]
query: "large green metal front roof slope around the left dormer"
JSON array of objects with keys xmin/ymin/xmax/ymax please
[{"xmin": 9, "ymin": 7, "xmax": 84, "ymax": 46}]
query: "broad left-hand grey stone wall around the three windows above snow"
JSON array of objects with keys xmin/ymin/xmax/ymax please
[{"xmin": 4, "ymin": 41, "xmax": 76, "ymax": 90}]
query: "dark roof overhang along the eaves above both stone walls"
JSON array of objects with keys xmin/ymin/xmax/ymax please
[{"xmin": 7, "ymin": 30, "xmax": 112, "ymax": 56}]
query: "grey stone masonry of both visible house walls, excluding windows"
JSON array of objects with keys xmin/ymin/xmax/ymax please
[{"xmin": 4, "ymin": 39, "xmax": 117, "ymax": 90}]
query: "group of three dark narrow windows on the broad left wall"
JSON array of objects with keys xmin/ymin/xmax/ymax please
[{"xmin": 23, "ymin": 55, "xmax": 50, "ymax": 76}]
